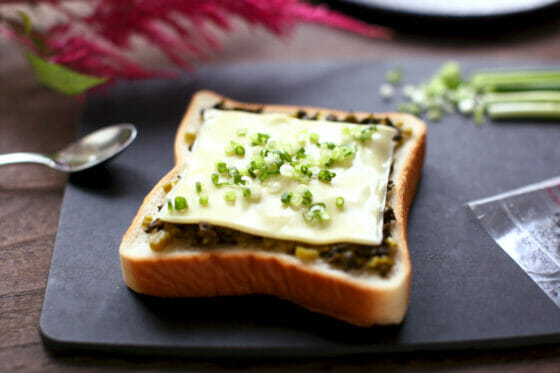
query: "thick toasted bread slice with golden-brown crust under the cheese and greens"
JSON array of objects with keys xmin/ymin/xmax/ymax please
[{"xmin": 119, "ymin": 91, "xmax": 426, "ymax": 326}]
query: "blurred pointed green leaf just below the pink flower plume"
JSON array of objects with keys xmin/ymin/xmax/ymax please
[{"xmin": 25, "ymin": 51, "xmax": 107, "ymax": 96}]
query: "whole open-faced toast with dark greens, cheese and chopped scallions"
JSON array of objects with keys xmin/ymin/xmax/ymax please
[{"xmin": 120, "ymin": 91, "xmax": 426, "ymax": 326}]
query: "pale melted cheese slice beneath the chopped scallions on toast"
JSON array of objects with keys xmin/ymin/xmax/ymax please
[{"xmin": 159, "ymin": 109, "xmax": 396, "ymax": 245}]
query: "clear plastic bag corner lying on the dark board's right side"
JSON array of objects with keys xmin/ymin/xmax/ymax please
[{"xmin": 468, "ymin": 177, "xmax": 560, "ymax": 307}]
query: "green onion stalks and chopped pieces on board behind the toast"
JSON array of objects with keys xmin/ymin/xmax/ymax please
[{"xmin": 383, "ymin": 62, "xmax": 560, "ymax": 124}]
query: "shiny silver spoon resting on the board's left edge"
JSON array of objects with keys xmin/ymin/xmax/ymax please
[{"xmin": 0, "ymin": 123, "xmax": 137, "ymax": 172}]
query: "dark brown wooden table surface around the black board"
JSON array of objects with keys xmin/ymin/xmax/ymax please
[{"xmin": 0, "ymin": 16, "xmax": 560, "ymax": 372}]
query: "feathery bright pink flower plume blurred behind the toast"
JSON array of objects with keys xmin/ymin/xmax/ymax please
[{"xmin": 0, "ymin": 0, "xmax": 390, "ymax": 88}]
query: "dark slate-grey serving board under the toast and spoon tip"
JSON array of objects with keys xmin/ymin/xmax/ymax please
[{"xmin": 40, "ymin": 61, "xmax": 560, "ymax": 357}]
